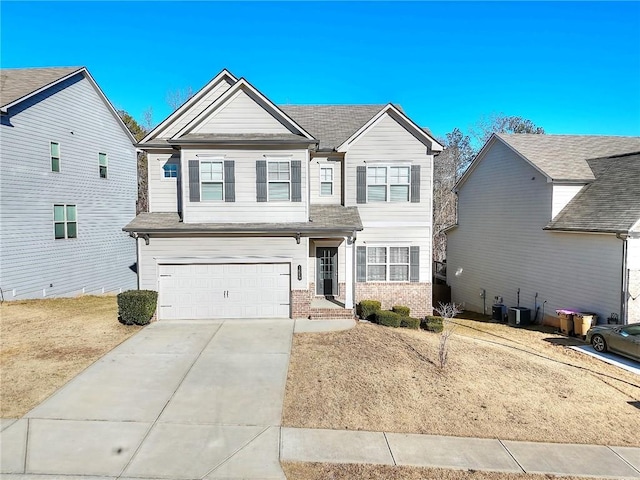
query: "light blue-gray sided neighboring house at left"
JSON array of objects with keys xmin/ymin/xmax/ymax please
[{"xmin": 0, "ymin": 67, "xmax": 137, "ymax": 300}]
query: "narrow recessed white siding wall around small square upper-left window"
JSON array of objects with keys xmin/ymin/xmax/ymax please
[{"xmin": 147, "ymin": 153, "xmax": 181, "ymax": 212}]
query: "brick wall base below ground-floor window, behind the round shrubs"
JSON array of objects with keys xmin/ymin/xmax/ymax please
[{"xmin": 356, "ymin": 283, "xmax": 433, "ymax": 317}]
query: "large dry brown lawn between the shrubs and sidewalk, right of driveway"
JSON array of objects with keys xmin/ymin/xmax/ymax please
[{"xmin": 283, "ymin": 319, "xmax": 640, "ymax": 446}]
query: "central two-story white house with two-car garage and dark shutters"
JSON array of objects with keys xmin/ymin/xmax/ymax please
[{"xmin": 125, "ymin": 70, "xmax": 442, "ymax": 319}]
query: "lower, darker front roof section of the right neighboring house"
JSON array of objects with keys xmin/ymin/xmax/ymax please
[{"xmin": 545, "ymin": 151, "xmax": 640, "ymax": 233}]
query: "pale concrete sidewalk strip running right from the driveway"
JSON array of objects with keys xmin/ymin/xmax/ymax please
[{"xmin": 280, "ymin": 428, "xmax": 640, "ymax": 480}]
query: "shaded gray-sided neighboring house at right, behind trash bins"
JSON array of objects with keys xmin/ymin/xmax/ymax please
[{"xmin": 447, "ymin": 134, "xmax": 640, "ymax": 325}]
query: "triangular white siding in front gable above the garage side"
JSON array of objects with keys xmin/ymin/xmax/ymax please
[{"xmin": 191, "ymin": 90, "xmax": 290, "ymax": 134}]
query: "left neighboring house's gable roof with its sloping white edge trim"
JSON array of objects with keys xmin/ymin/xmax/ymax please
[{"xmin": 0, "ymin": 67, "xmax": 136, "ymax": 144}]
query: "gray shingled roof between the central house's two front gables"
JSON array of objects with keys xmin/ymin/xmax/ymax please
[{"xmin": 278, "ymin": 105, "xmax": 385, "ymax": 150}]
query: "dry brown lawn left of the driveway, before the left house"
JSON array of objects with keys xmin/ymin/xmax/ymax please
[{"xmin": 0, "ymin": 296, "xmax": 140, "ymax": 418}]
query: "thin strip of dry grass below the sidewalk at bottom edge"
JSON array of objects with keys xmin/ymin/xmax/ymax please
[{"xmin": 282, "ymin": 462, "xmax": 596, "ymax": 480}]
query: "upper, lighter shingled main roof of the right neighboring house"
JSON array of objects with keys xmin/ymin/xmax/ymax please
[{"xmin": 497, "ymin": 133, "xmax": 640, "ymax": 181}]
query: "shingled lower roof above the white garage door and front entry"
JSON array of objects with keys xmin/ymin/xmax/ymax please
[{"xmin": 123, "ymin": 205, "xmax": 362, "ymax": 235}]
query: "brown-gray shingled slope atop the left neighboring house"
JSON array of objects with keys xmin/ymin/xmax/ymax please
[{"xmin": 0, "ymin": 67, "xmax": 83, "ymax": 107}]
